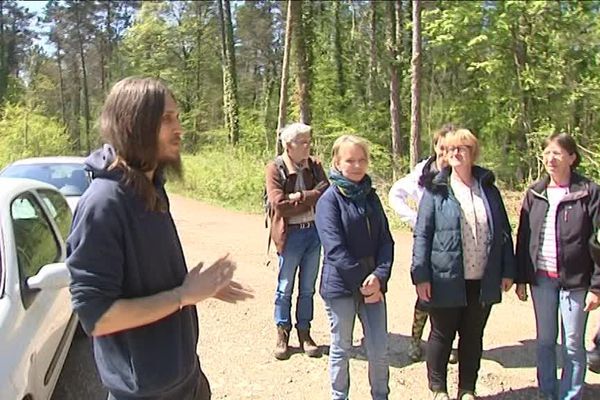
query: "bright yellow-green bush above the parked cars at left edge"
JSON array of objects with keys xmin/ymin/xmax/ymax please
[{"xmin": 0, "ymin": 104, "xmax": 71, "ymax": 167}]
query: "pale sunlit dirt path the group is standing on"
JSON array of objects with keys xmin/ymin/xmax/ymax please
[{"xmin": 165, "ymin": 196, "xmax": 600, "ymax": 400}]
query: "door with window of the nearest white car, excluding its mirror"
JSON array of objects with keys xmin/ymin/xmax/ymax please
[{"xmin": 11, "ymin": 190, "xmax": 72, "ymax": 399}]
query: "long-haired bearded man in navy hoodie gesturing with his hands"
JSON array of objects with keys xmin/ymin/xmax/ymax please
[{"xmin": 67, "ymin": 78, "xmax": 251, "ymax": 400}]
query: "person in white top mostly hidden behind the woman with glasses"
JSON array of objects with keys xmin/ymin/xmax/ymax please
[{"xmin": 389, "ymin": 124, "xmax": 457, "ymax": 364}]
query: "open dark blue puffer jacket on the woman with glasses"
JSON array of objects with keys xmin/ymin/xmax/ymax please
[{"xmin": 411, "ymin": 166, "xmax": 516, "ymax": 307}]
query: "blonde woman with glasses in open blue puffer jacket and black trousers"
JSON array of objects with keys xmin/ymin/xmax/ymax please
[{"xmin": 411, "ymin": 129, "xmax": 516, "ymax": 400}]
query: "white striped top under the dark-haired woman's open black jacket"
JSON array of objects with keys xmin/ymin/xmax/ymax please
[{"xmin": 536, "ymin": 186, "xmax": 569, "ymax": 275}]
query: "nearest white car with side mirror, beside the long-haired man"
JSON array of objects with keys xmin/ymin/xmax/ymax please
[{"xmin": 0, "ymin": 177, "xmax": 78, "ymax": 400}]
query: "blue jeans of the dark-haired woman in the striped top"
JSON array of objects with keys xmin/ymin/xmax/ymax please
[{"xmin": 531, "ymin": 275, "xmax": 588, "ymax": 400}]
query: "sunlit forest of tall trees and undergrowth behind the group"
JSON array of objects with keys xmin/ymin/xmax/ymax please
[{"xmin": 0, "ymin": 0, "xmax": 600, "ymax": 210}]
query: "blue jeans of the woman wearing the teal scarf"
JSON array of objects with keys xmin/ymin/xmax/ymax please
[{"xmin": 325, "ymin": 297, "xmax": 390, "ymax": 400}]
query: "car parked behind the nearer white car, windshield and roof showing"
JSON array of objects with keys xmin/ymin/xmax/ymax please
[{"xmin": 0, "ymin": 156, "xmax": 91, "ymax": 212}]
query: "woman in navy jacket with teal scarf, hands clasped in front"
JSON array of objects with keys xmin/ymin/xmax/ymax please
[{"xmin": 315, "ymin": 135, "xmax": 394, "ymax": 400}]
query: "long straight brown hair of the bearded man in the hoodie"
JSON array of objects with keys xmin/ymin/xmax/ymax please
[{"xmin": 100, "ymin": 77, "xmax": 173, "ymax": 211}]
